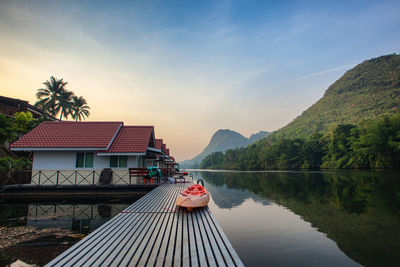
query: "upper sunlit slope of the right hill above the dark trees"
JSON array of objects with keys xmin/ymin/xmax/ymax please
[{"xmin": 271, "ymin": 54, "xmax": 400, "ymax": 139}]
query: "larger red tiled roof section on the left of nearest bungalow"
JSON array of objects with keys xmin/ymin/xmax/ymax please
[{"xmin": 10, "ymin": 121, "xmax": 123, "ymax": 149}]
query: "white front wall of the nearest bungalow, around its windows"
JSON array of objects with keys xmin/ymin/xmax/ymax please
[{"xmin": 32, "ymin": 151, "xmax": 138, "ymax": 170}]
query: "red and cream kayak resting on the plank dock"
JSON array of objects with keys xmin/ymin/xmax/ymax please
[{"xmin": 176, "ymin": 184, "xmax": 210, "ymax": 211}]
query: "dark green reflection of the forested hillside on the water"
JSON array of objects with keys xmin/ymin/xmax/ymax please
[{"xmin": 192, "ymin": 171, "xmax": 400, "ymax": 266}]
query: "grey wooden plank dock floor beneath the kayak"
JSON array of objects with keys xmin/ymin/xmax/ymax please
[{"xmin": 46, "ymin": 183, "xmax": 243, "ymax": 266}]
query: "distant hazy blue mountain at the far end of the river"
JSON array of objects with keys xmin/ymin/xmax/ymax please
[{"xmin": 179, "ymin": 129, "xmax": 269, "ymax": 168}]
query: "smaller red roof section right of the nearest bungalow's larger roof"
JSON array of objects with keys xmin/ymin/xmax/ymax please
[{"xmin": 105, "ymin": 126, "xmax": 154, "ymax": 153}]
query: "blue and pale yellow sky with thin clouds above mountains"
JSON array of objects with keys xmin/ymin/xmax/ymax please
[{"xmin": 0, "ymin": 0, "xmax": 400, "ymax": 161}]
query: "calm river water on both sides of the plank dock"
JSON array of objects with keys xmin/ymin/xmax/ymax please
[{"xmin": 0, "ymin": 171, "xmax": 400, "ymax": 266}]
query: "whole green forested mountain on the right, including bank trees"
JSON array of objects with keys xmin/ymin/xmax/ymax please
[{"xmin": 200, "ymin": 54, "xmax": 400, "ymax": 170}]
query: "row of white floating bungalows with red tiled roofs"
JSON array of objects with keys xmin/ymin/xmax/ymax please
[{"xmin": 10, "ymin": 121, "xmax": 177, "ymax": 185}]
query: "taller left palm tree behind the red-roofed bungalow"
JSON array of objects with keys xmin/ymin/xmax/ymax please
[{"xmin": 35, "ymin": 76, "xmax": 68, "ymax": 117}]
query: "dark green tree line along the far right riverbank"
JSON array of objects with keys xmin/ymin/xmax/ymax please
[{"xmin": 200, "ymin": 113, "xmax": 400, "ymax": 170}]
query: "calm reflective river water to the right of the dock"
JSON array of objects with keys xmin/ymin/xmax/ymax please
[{"xmin": 194, "ymin": 171, "xmax": 400, "ymax": 266}]
